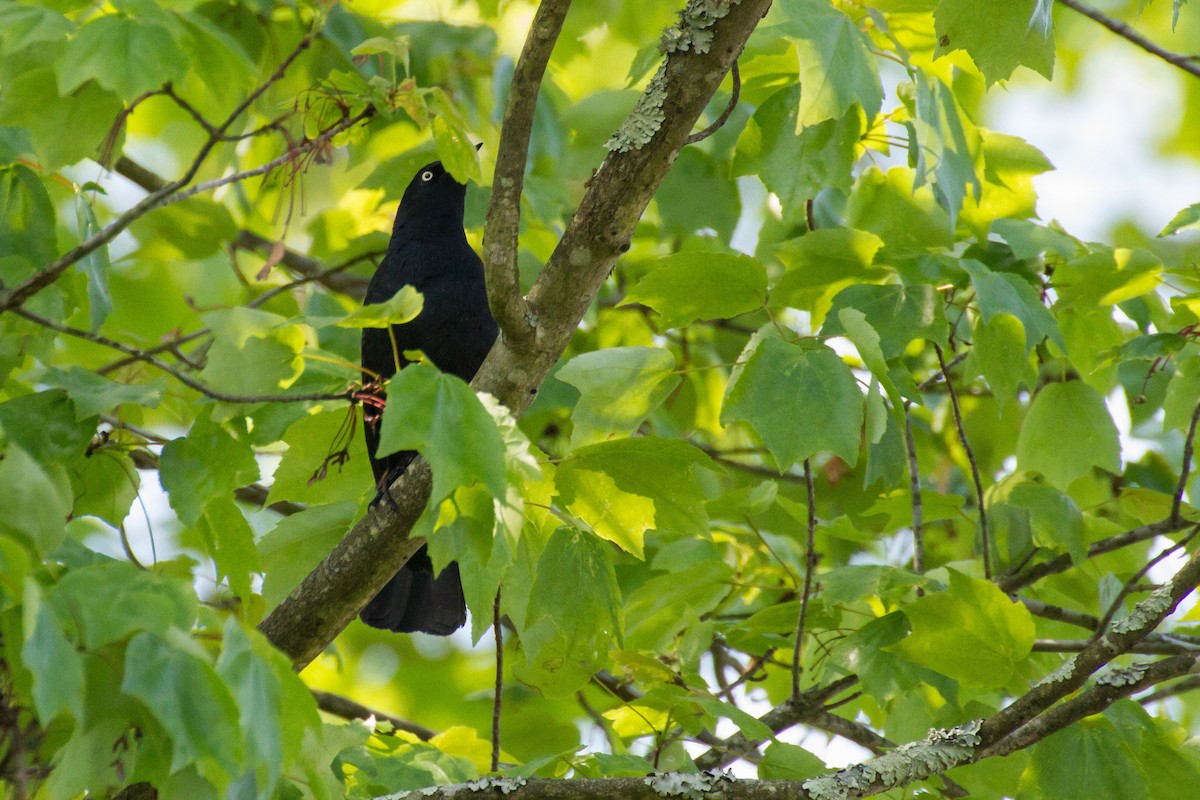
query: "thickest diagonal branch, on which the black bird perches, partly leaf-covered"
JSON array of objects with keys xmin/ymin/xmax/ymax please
[{"xmin": 259, "ymin": 0, "xmax": 770, "ymax": 667}]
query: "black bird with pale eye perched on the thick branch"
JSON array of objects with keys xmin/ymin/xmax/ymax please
[{"xmin": 361, "ymin": 155, "xmax": 498, "ymax": 636}]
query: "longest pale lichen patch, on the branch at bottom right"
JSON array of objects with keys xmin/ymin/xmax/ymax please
[{"xmin": 803, "ymin": 720, "xmax": 980, "ymax": 800}]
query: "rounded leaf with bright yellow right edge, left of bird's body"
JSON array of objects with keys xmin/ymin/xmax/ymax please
[{"xmin": 200, "ymin": 306, "xmax": 305, "ymax": 395}]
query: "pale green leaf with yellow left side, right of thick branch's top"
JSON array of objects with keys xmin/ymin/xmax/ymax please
[{"xmin": 772, "ymin": 0, "xmax": 883, "ymax": 130}]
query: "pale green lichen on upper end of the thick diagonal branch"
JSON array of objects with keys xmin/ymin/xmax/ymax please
[{"xmin": 604, "ymin": 0, "xmax": 740, "ymax": 152}]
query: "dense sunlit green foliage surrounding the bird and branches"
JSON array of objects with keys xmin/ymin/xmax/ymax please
[{"xmin": 0, "ymin": 0, "xmax": 1200, "ymax": 800}]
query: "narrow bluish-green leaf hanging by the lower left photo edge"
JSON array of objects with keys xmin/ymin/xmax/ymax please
[{"xmin": 20, "ymin": 581, "xmax": 88, "ymax": 726}]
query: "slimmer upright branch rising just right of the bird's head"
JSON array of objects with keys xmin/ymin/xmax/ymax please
[{"xmin": 484, "ymin": 0, "xmax": 571, "ymax": 347}]
